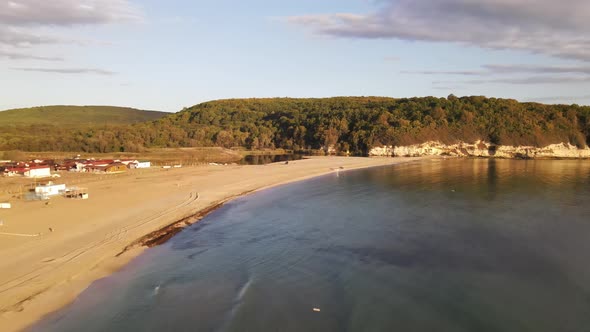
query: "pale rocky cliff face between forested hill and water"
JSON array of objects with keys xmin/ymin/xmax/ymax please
[{"xmin": 369, "ymin": 141, "xmax": 590, "ymax": 159}]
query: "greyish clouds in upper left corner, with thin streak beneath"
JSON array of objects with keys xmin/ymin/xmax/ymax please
[{"xmin": 0, "ymin": 0, "xmax": 142, "ymax": 75}]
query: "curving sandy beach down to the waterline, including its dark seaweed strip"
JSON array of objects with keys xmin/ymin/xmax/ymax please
[{"xmin": 0, "ymin": 157, "xmax": 430, "ymax": 331}]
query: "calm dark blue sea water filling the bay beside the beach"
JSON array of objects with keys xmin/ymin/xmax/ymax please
[{"xmin": 32, "ymin": 160, "xmax": 590, "ymax": 332}]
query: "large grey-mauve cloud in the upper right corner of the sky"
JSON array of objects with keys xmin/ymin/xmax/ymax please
[{"xmin": 287, "ymin": 0, "xmax": 590, "ymax": 61}]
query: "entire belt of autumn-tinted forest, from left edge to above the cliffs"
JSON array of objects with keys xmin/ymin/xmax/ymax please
[{"xmin": 0, "ymin": 95, "xmax": 590, "ymax": 155}]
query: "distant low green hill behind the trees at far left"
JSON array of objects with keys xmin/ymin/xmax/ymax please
[{"xmin": 0, "ymin": 106, "xmax": 168, "ymax": 126}]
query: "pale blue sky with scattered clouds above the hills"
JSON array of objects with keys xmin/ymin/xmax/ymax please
[{"xmin": 0, "ymin": 0, "xmax": 590, "ymax": 112}]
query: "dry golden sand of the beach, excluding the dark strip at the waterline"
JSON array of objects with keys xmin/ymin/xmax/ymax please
[{"xmin": 0, "ymin": 157, "xmax": 426, "ymax": 331}]
